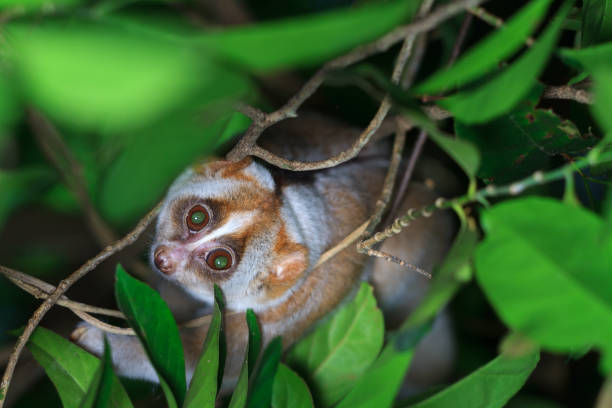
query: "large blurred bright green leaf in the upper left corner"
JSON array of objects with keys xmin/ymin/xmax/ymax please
[{"xmin": 6, "ymin": 20, "xmax": 245, "ymax": 131}]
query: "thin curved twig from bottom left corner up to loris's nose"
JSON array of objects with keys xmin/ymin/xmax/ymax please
[{"xmin": 0, "ymin": 203, "xmax": 161, "ymax": 408}]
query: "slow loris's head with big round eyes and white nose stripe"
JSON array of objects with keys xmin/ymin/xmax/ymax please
[{"xmin": 151, "ymin": 158, "xmax": 308, "ymax": 310}]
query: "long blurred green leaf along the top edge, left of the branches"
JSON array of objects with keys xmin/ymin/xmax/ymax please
[{"xmin": 196, "ymin": 0, "xmax": 420, "ymax": 71}]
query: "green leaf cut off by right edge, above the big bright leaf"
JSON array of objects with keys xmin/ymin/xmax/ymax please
[{"xmin": 561, "ymin": 42, "xmax": 612, "ymax": 140}]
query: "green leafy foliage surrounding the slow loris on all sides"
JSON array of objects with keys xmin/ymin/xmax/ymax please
[{"xmin": 0, "ymin": 0, "xmax": 612, "ymax": 408}]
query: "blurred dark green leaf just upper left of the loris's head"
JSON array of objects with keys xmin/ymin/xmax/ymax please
[{"xmin": 99, "ymin": 114, "xmax": 233, "ymax": 224}]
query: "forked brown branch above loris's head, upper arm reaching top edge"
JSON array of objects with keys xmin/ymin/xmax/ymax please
[{"xmin": 227, "ymin": 0, "xmax": 483, "ymax": 171}]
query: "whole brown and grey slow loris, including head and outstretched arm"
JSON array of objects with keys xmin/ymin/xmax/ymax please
[{"xmin": 75, "ymin": 115, "xmax": 451, "ymax": 388}]
